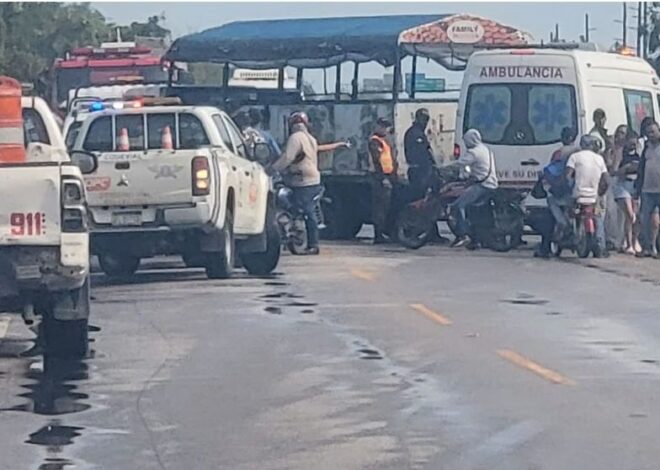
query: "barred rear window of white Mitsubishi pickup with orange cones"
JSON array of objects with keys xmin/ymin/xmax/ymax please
[{"xmin": 83, "ymin": 113, "xmax": 210, "ymax": 152}]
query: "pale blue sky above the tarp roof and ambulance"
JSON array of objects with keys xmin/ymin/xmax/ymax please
[{"xmin": 92, "ymin": 2, "xmax": 624, "ymax": 46}]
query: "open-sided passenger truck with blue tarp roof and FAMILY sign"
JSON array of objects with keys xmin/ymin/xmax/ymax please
[{"xmin": 164, "ymin": 14, "xmax": 531, "ymax": 239}]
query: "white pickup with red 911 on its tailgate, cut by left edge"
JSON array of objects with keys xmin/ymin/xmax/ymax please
[{"xmin": 0, "ymin": 96, "xmax": 96, "ymax": 357}]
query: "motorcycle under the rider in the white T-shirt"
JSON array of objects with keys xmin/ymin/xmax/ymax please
[{"xmin": 552, "ymin": 204, "xmax": 601, "ymax": 258}]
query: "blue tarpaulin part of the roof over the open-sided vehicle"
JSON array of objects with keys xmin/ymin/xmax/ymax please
[{"xmin": 165, "ymin": 15, "xmax": 451, "ymax": 68}]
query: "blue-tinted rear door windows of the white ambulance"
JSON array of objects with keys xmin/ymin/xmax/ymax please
[{"xmin": 463, "ymin": 83, "xmax": 577, "ymax": 145}]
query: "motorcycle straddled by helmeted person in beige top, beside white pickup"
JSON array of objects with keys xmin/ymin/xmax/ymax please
[{"xmin": 274, "ymin": 180, "xmax": 324, "ymax": 255}]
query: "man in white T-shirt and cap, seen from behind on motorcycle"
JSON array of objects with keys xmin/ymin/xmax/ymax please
[{"xmin": 566, "ymin": 135, "xmax": 609, "ymax": 253}]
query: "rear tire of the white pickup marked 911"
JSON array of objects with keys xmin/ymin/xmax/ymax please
[{"xmin": 42, "ymin": 279, "xmax": 90, "ymax": 359}]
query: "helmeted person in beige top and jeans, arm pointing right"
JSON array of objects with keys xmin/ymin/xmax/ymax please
[{"xmin": 271, "ymin": 111, "xmax": 349, "ymax": 255}]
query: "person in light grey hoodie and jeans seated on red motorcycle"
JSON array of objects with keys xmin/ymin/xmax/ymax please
[{"xmin": 450, "ymin": 129, "xmax": 499, "ymax": 247}]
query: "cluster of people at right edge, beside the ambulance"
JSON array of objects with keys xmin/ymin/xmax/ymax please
[{"xmin": 533, "ymin": 109, "xmax": 660, "ymax": 257}]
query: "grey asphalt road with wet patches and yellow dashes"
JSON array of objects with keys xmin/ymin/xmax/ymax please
[{"xmin": 0, "ymin": 243, "xmax": 660, "ymax": 470}]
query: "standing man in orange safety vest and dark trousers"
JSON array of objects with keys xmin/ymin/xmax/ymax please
[{"xmin": 369, "ymin": 118, "xmax": 399, "ymax": 244}]
